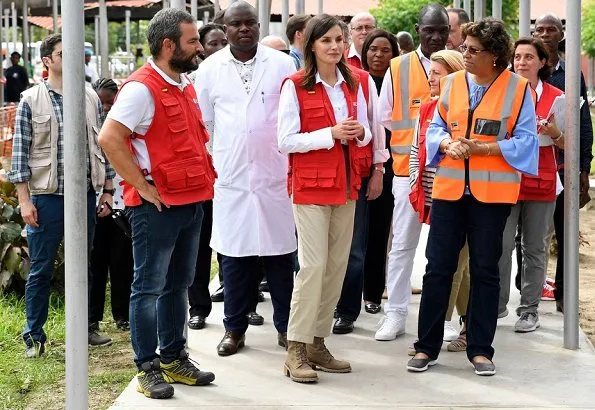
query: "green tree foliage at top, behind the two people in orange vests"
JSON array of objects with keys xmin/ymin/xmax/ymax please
[{"xmin": 371, "ymin": 0, "xmax": 519, "ymax": 42}]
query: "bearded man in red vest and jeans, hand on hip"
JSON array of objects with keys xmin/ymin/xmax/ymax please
[{"xmin": 99, "ymin": 8, "xmax": 215, "ymax": 399}]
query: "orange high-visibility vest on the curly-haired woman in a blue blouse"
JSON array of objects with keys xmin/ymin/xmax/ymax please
[{"xmin": 432, "ymin": 70, "xmax": 528, "ymax": 204}]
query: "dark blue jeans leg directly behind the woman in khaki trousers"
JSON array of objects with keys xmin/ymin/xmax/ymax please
[{"xmin": 337, "ymin": 178, "xmax": 369, "ymax": 322}]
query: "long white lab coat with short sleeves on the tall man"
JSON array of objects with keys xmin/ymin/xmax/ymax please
[{"xmin": 195, "ymin": 45, "xmax": 297, "ymax": 257}]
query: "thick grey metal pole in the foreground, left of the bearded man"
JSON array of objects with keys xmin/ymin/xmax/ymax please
[{"xmin": 62, "ymin": 0, "xmax": 89, "ymax": 404}]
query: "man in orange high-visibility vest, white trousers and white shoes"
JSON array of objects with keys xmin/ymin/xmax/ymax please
[{"xmin": 375, "ymin": 3, "xmax": 449, "ymax": 340}]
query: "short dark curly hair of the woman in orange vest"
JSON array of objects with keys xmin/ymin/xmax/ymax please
[{"xmin": 462, "ymin": 17, "xmax": 512, "ymax": 68}]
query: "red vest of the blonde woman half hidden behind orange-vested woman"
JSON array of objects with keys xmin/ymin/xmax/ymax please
[{"xmin": 409, "ymin": 99, "xmax": 438, "ymax": 224}]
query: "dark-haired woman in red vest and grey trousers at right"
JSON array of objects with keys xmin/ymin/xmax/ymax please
[{"xmin": 499, "ymin": 37, "xmax": 564, "ymax": 333}]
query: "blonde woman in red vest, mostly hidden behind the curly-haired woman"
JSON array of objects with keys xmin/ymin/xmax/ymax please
[{"xmin": 409, "ymin": 50, "xmax": 469, "ymax": 356}]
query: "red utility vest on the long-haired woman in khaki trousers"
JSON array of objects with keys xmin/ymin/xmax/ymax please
[{"xmin": 285, "ymin": 70, "xmax": 361, "ymax": 205}]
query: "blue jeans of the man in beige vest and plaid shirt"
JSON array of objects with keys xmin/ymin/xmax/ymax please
[{"xmin": 23, "ymin": 190, "xmax": 95, "ymax": 347}]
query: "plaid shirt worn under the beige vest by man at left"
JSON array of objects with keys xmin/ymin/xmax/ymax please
[{"xmin": 8, "ymin": 81, "xmax": 116, "ymax": 195}]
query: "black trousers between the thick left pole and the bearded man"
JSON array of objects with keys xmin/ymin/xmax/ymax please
[{"xmin": 89, "ymin": 216, "xmax": 134, "ymax": 323}]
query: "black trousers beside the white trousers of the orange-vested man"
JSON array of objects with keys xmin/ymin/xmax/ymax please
[{"xmin": 364, "ymin": 176, "xmax": 395, "ymax": 304}]
